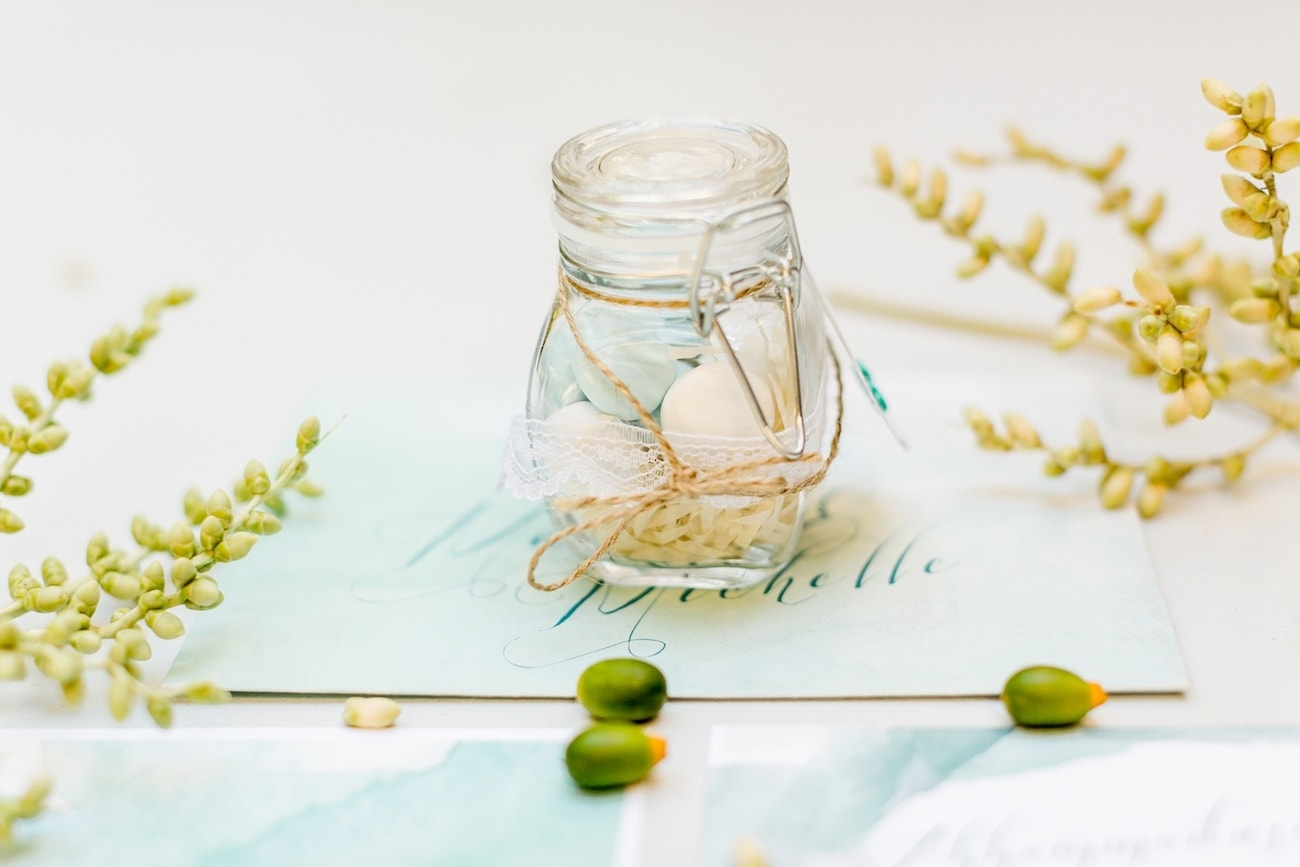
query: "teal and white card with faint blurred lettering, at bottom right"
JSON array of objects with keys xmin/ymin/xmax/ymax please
[{"xmin": 701, "ymin": 725, "xmax": 1300, "ymax": 867}]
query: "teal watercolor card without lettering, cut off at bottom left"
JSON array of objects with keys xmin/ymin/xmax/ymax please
[{"xmin": 0, "ymin": 729, "xmax": 640, "ymax": 867}]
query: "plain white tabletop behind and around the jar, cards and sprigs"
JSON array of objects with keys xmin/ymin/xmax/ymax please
[{"xmin": 0, "ymin": 0, "xmax": 1300, "ymax": 864}]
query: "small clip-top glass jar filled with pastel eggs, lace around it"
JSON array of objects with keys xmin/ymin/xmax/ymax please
[{"xmin": 507, "ymin": 120, "xmax": 829, "ymax": 588}]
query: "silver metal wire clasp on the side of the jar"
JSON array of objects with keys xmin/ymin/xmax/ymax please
[{"xmin": 688, "ymin": 199, "xmax": 807, "ymax": 460}]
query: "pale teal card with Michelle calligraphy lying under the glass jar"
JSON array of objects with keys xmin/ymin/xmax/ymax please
[{"xmin": 169, "ymin": 380, "xmax": 1186, "ymax": 698}]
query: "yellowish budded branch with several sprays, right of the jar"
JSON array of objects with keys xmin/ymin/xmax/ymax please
[{"xmin": 875, "ymin": 79, "xmax": 1300, "ymax": 517}]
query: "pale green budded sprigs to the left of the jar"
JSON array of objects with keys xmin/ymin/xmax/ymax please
[{"xmin": 0, "ymin": 290, "xmax": 322, "ymax": 840}]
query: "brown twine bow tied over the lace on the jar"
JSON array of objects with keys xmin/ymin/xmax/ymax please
[{"xmin": 528, "ymin": 272, "xmax": 844, "ymax": 590}]
